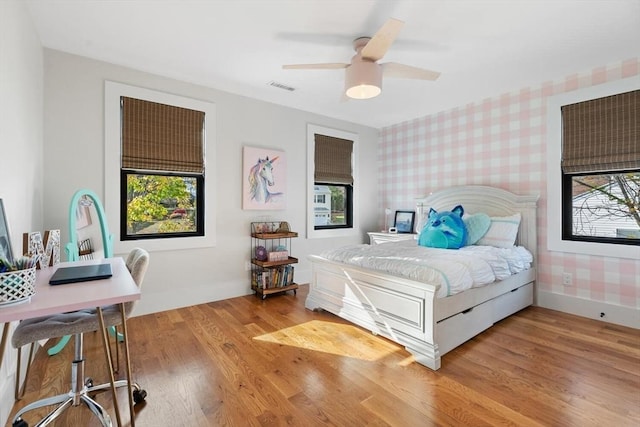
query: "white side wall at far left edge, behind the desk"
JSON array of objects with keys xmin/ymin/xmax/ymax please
[{"xmin": 0, "ymin": 0, "xmax": 43, "ymax": 425}]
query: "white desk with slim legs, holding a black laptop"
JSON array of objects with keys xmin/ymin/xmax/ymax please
[{"xmin": 0, "ymin": 257, "xmax": 140, "ymax": 426}]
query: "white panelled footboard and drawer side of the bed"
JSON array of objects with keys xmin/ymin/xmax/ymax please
[{"xmin": 305, "ymin": 255, "xmax": 535, "ymax": 370}]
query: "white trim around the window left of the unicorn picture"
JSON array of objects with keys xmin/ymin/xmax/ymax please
[{"xmin": 104, "ymin": 81, "xmax": 217, "ymax": 253}]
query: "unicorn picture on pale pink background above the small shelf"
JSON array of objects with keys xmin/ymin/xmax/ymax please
[{"xmin": 242, "ymin": 146, "xmax": 287, "ymax": 210}]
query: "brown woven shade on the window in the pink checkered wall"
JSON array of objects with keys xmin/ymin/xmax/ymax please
[{"xmin": 561, "ymin": 90, "xmax": 640, "ymax": 174}]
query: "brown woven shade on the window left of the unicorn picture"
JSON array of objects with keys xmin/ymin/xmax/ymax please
[{"xmin": 121, "ymin": 97, "xmax": 204, "ymax": 173}]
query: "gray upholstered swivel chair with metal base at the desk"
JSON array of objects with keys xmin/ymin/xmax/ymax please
[{"xmin": 11, "ymin": 248, "xmax": 149, "ymax": 427}]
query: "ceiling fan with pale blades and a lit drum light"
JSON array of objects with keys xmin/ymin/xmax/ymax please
[{"xmin": 282, "ymin": 18, "xmax": 440, "ymax": 99}]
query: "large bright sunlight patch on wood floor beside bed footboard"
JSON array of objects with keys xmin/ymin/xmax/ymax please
[{"xmin": 253, "ymin": 320, "xmax": 399, "ymax": 361}]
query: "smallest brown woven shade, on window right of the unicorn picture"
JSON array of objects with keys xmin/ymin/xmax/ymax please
[{"xmin": 314, "ymin": 134, "xmax": 353, "ymax": 185}]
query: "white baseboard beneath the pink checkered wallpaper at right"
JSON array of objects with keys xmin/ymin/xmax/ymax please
[{"xmin": 536, "ymin": 291, "xmax": 640, "ymax": 329}]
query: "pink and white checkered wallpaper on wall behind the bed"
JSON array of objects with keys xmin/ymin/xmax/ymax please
[{"xmin": 378, "ymin": 58, "xmax": 640, "ymax": 308}]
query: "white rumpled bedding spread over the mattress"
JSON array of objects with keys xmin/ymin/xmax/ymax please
[{"xmin": 320, "ymin": 240, "xmax": 533, "ymax": 298}]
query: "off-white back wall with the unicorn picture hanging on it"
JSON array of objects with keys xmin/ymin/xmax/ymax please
[{"xmin": 44, "ymin": 49, "xmax": 378, "ymax": 314}]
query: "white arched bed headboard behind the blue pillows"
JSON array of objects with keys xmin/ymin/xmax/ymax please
[{"xmin": 416, "ymin": 185, "xmax": 539, "ymax": 262}]
